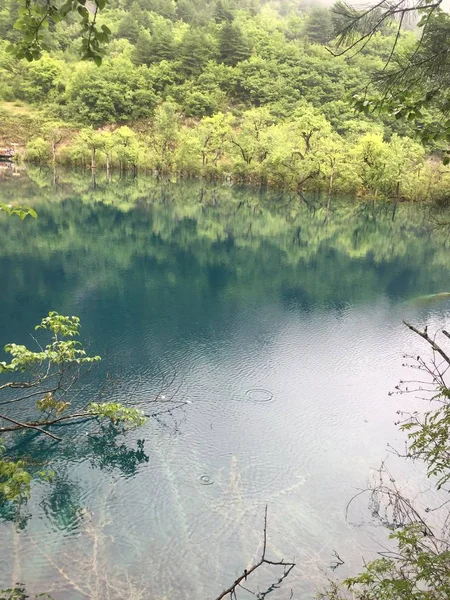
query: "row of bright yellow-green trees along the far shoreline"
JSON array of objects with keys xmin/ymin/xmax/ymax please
[{"xmin": 21, "ymin": 98, "xmax": 450, "ymax": 200}]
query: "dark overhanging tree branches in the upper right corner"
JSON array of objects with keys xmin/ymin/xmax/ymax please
[{"xmin": 333, "ymin": 0, "xmax": 450, "ymax": 162}]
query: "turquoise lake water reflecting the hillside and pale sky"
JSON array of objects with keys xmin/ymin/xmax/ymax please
[{"xmin": 0, "ymin": 171, "xmax": 450, "ymax": 600}]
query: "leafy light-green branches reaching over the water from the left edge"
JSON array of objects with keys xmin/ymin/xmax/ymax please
[{"xmin": 0, "ymin": 312, "xmax": 145, "ymax": 503}]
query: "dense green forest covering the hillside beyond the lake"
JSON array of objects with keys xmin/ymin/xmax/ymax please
[{"xmin": 0, "ymin": 0, "xmax": 450, "ymax": 200}]
